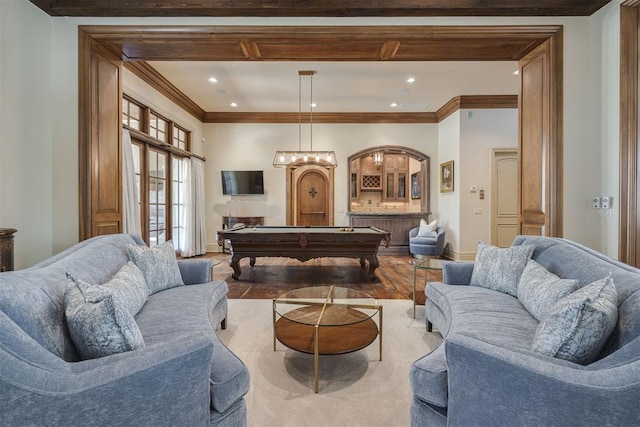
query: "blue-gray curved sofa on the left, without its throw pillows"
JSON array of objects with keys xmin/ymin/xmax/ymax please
[{"xmin": 0, "ymin": 234, "xmax": 249, "ymax": 427}]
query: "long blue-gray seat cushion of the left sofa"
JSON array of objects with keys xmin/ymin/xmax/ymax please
[{"xmin": 136, "ymin": 281, "xmax": 249, "ymax": 412}]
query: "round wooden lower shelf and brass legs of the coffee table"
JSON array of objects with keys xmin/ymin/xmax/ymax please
[{"xmin": 273, "ymin": 305, "xmax": 382, "ymax": 393}]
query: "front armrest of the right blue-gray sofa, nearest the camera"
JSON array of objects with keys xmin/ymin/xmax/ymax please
[{"xmin": 445, "ymin": 334, "xmax": 640, "ymax": 426}]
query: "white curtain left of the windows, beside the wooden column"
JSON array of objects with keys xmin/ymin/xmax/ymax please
[{"xmin": 122, "ymin": 129, "xmax": 142, "ymax": 234}]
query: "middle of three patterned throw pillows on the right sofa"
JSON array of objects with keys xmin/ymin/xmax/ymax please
[{"xmin": 518, "ymin": 259, "xmax": 578, "ymax": 321}]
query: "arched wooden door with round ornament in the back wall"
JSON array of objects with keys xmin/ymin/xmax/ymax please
[{"xmin": 296, "ymin": 169, "xmax": 331, "ymax": 226}]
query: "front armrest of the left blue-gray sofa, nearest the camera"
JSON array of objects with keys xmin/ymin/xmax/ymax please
[{"xmin": 0, "ymin": 334, "xmax": 213, "ymax": 426}]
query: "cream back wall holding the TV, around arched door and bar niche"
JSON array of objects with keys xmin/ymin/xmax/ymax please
[{"xmin": 204, "ymin": 124, "xmax": 438, "ymax": 250}]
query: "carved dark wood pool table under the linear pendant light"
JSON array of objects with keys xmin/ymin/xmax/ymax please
[{"xmin": 218, "ymin": 226, "xmax": 391, "ymax": 280}]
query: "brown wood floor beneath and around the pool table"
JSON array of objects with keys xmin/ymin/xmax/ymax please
[{"xmin": 196, "ymin": 253, "xmax": 442, "ymax": 302}]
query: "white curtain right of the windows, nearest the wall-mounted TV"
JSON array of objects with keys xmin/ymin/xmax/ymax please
[{"xmin": 180, "ymin": 158, "xmax": 207, "ymax": 257}]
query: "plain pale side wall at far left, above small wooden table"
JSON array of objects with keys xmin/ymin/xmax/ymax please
[{"xmin": 0, "ymin": 1, "xmax": 53, "ymax": 268}]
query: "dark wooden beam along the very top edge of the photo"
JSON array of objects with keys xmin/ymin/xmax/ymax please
[{"xmin": 30, "ymin": 0, "xmax": 610, "ymax": 17}]
